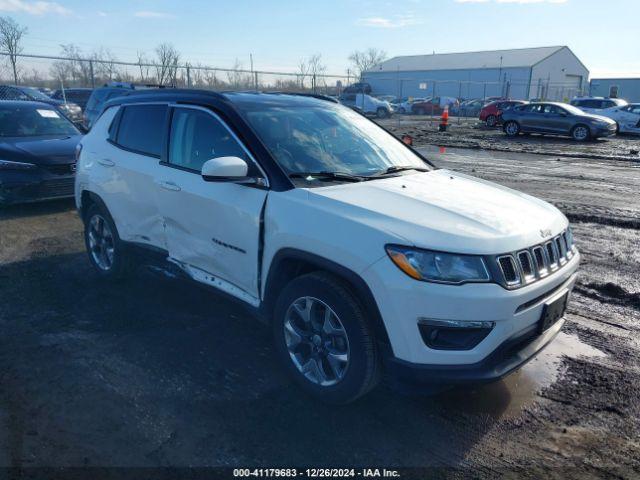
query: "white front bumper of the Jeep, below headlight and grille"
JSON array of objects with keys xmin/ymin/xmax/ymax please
[{"xmin": 363, "ymin": 252, "xmax": 580, "ymax": 370}]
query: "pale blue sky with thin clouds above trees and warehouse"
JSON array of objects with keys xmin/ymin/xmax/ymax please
[{"xmin": 0, "ymin": 0, "xmax": 640, "ymax": 76}]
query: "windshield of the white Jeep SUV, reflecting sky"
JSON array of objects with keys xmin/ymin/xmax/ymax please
[{"xmin": 240, "ymin": 102, "xmax": 429, "ymax": 176}]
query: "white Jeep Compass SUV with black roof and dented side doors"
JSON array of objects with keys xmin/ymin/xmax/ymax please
[{"xmin": 75, "ymin": 90, "xmax": 579, "ymax": 403}]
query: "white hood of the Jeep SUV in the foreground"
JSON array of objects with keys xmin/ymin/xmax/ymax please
[{"xmin": 309, "ymin": 170, "xmax": 568, "ymax": 254}]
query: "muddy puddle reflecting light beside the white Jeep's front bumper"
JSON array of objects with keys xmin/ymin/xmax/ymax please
[{"xmin": 435, "ymin": 332, "xmax": 606, "ymax": 419}]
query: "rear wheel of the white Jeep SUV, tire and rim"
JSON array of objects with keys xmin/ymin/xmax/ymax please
[{"xmin": 84, "ymin": 203, "xmax": 133, "ymax": 281}]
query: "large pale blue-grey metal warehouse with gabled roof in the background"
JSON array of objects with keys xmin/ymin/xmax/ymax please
[{"xmin": 363, "ymin": 46, "xmax": 589, "ymax": 100}]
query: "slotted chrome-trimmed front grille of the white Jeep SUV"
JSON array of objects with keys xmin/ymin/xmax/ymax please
[{"xmin": 496, "ymin": 229, "xmax": 575, "ymax": 288}]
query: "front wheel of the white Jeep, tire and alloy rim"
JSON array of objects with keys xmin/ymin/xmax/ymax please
[{"xmin": 273, "ymin": 272, "xmax": 380, "ymax": 404}]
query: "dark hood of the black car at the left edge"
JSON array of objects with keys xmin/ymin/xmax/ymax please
[{"xmin": 0, "ymin": 135, "xmax": 82, "ymax": 165}]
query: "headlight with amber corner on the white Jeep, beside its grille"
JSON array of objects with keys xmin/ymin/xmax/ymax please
[{"xmin": 386, "ymin": 245, "xmax": 491, "ymax": 284}]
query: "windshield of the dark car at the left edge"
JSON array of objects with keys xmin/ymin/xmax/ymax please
[{"xmin": 0, "ymin": 105, "xmax": 80, "ymax": 137}]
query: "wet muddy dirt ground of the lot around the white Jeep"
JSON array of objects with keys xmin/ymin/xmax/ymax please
[{"xmin": 0, "ymin": 139, "xmax": 640, "ymax": 479}]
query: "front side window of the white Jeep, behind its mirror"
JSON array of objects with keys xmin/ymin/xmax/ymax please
[{"xmin": 169, "ymin": 108, "xmax": 249, "ymax": 172}]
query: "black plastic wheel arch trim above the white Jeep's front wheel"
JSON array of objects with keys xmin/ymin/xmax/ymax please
[{"xmin": 262, "ymin": 248, "xmax": 391, "ymax": 352}]
